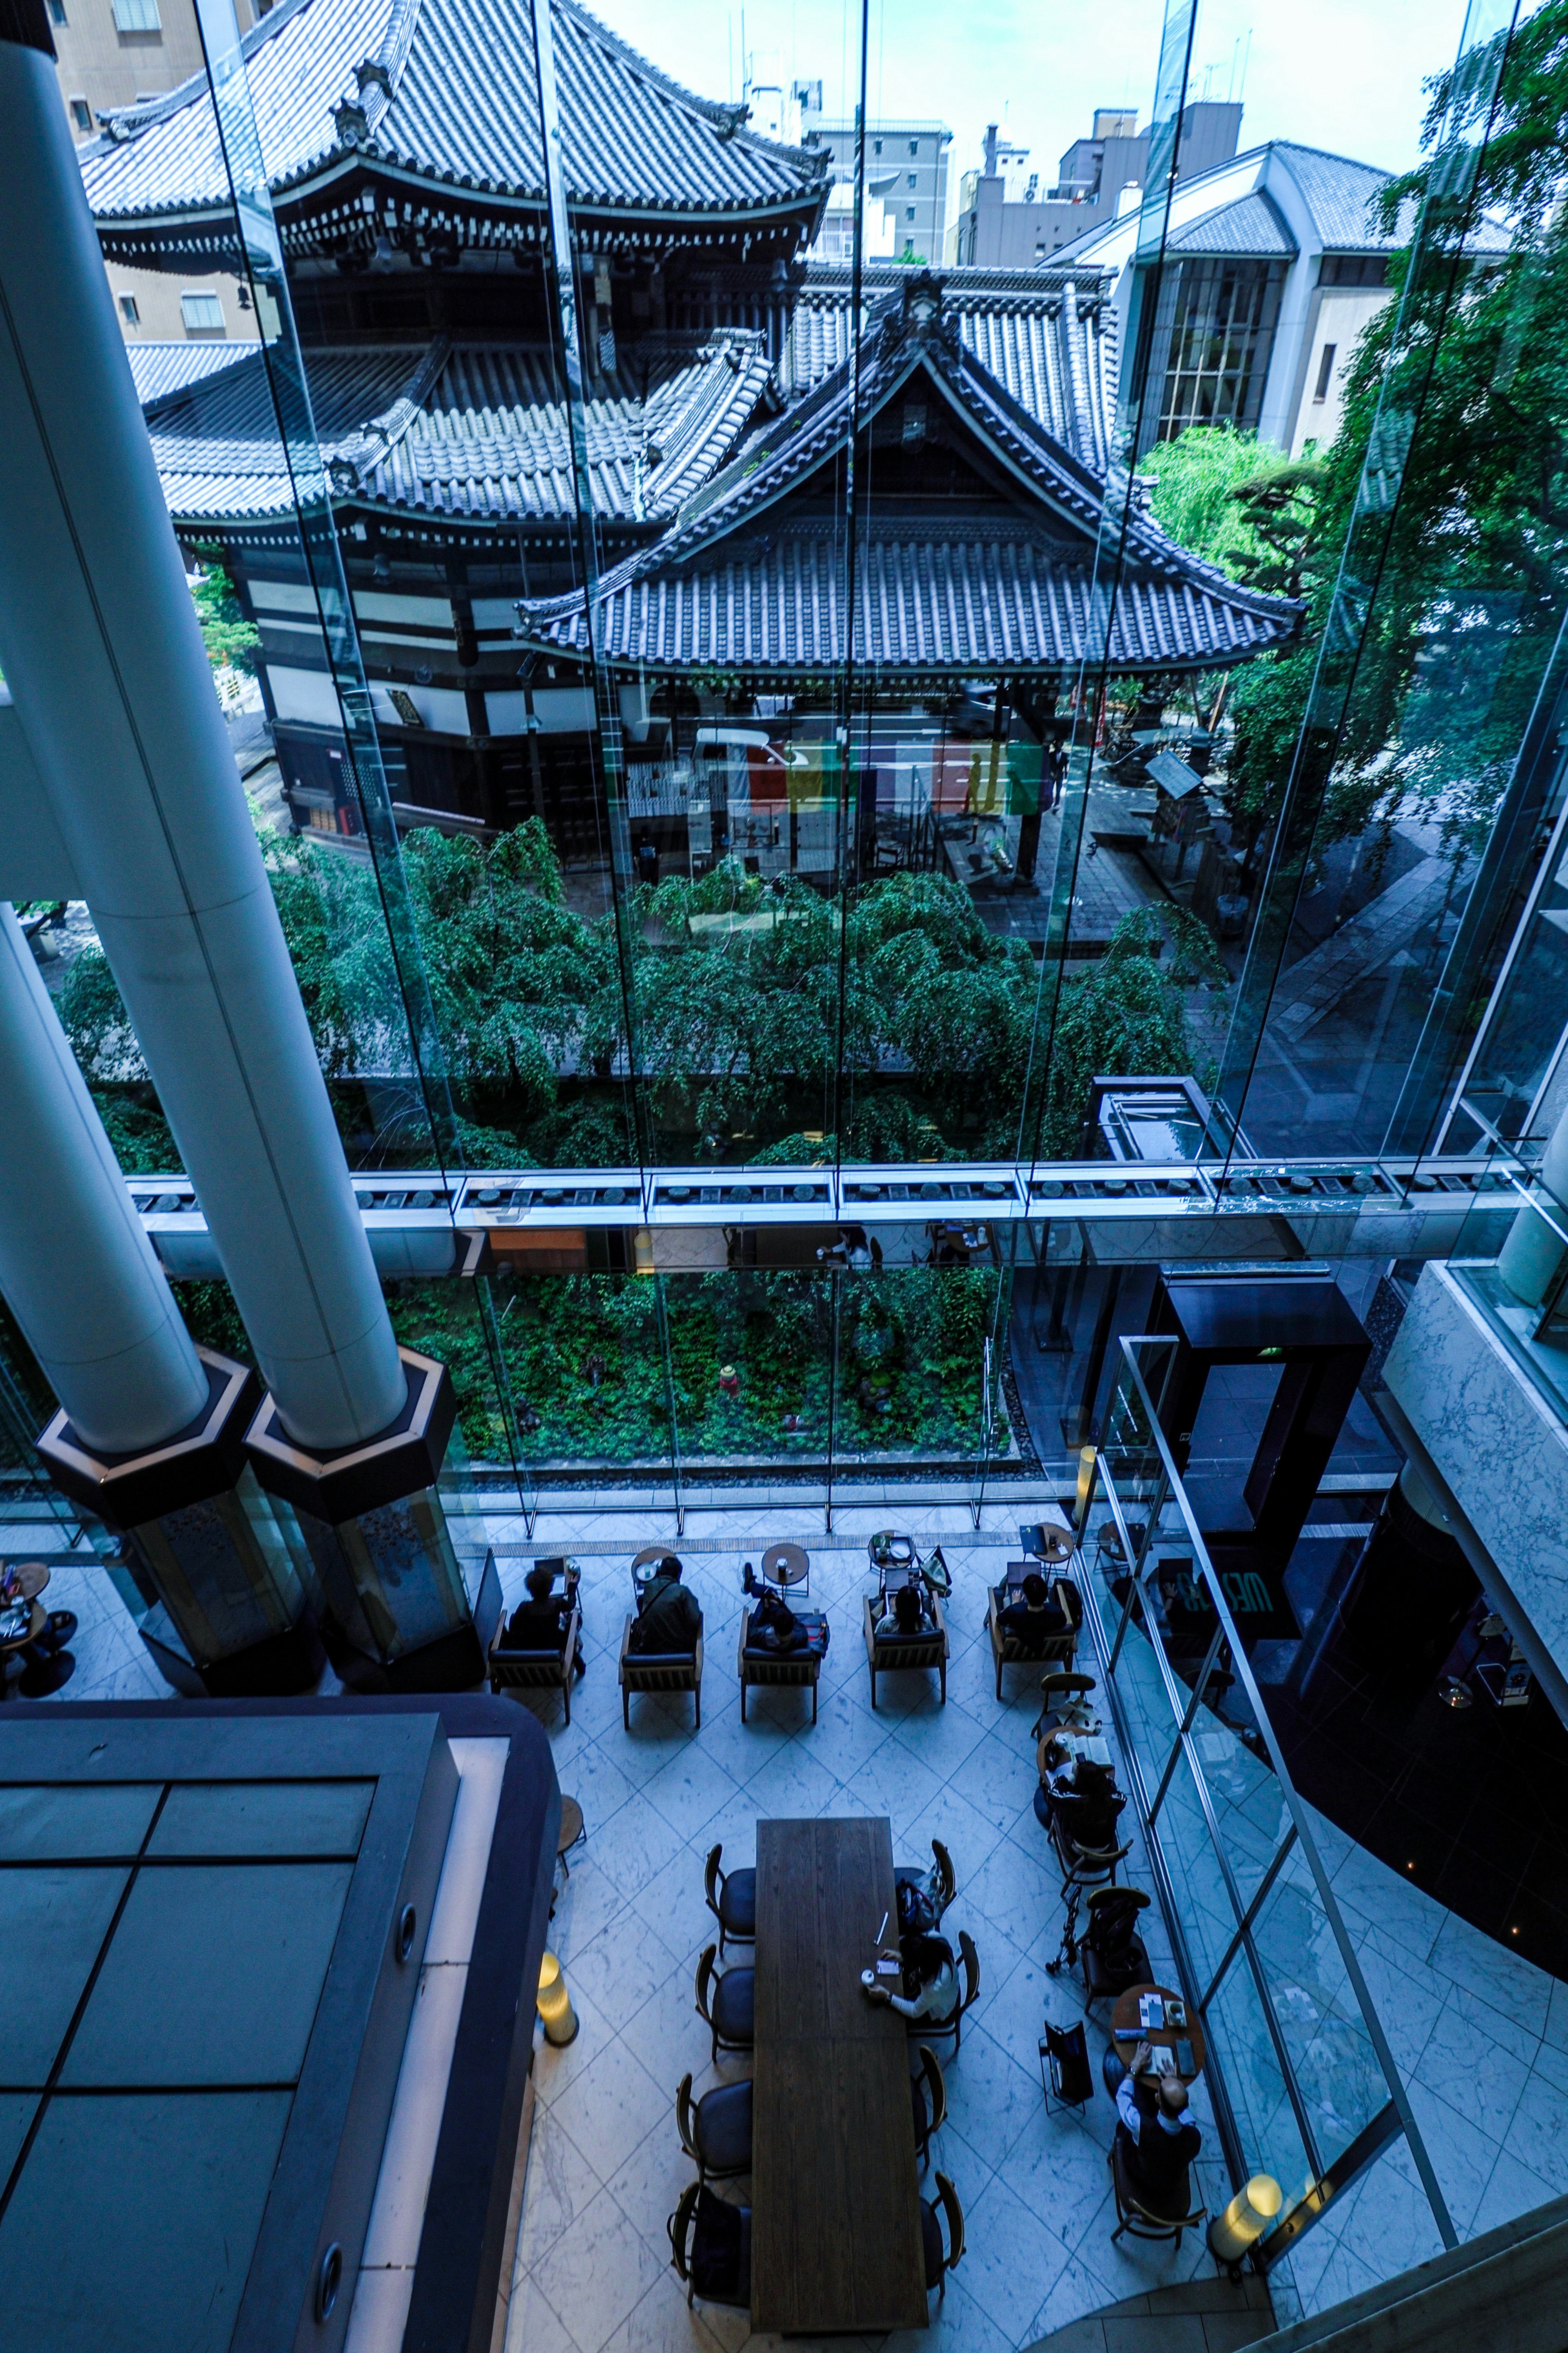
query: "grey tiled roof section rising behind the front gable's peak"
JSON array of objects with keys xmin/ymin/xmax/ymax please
[{"xmin": 778, "ymin": 261, "xmax": 1117, "ymax": 466}]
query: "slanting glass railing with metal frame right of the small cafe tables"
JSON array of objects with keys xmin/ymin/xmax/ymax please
[{"xmin": 1081, "ymin": 1336, "xmax": 1457, "ymax": 2270}]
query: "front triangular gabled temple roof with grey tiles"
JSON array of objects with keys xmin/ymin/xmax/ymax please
[{"xmin": 517, "ymin": 273, "xmax": 1302, "ymax": 678}]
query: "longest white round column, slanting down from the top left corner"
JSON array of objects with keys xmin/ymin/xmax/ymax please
[{"xmin": 0, "ymin": 40, "xmax": 407, "ymax": 1447}]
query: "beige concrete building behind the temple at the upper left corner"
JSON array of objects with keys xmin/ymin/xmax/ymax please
[{"xmin": 49, "ymin": 0, "xmax": 266, "ymax": 343}]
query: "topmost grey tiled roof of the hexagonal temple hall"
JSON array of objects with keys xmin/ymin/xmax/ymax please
[{"xmin": 82, "ymin": 0, "xmax": 830, "ymax": 259}]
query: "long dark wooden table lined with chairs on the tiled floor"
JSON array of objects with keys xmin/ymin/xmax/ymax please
[{"xmin": 752, "ymin": 1816, "xmax": 929, "ymax": 2334}]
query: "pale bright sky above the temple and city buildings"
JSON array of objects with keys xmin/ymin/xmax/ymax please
[{"xmin": 588, "ymin": 0, "xmax": 1465, "ymax": 186}]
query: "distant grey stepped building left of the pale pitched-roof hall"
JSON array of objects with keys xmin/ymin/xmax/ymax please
[{"xmin": 947, "ymin": 99, "xmax": 1241, "ymax": 271}]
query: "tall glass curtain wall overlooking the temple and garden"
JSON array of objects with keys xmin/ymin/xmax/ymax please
[{"xmin": 9, "ymin": 0, "xmax": 1568, "ymax": 1480}]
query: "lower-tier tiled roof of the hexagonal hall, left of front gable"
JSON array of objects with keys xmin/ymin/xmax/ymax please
[{"xmin": 131, "ymin": 330, "xmax": 769, "ymax": 529}]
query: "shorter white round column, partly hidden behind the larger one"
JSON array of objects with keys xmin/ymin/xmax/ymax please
[{"xmin": 0, "ymin": 899, "xmax": 207, "ymax": 1454}]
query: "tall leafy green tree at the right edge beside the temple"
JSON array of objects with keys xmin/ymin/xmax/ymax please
[{"xmin": 1229, "ymin": 0, "xmax": 1568, "ymax": 854}]
